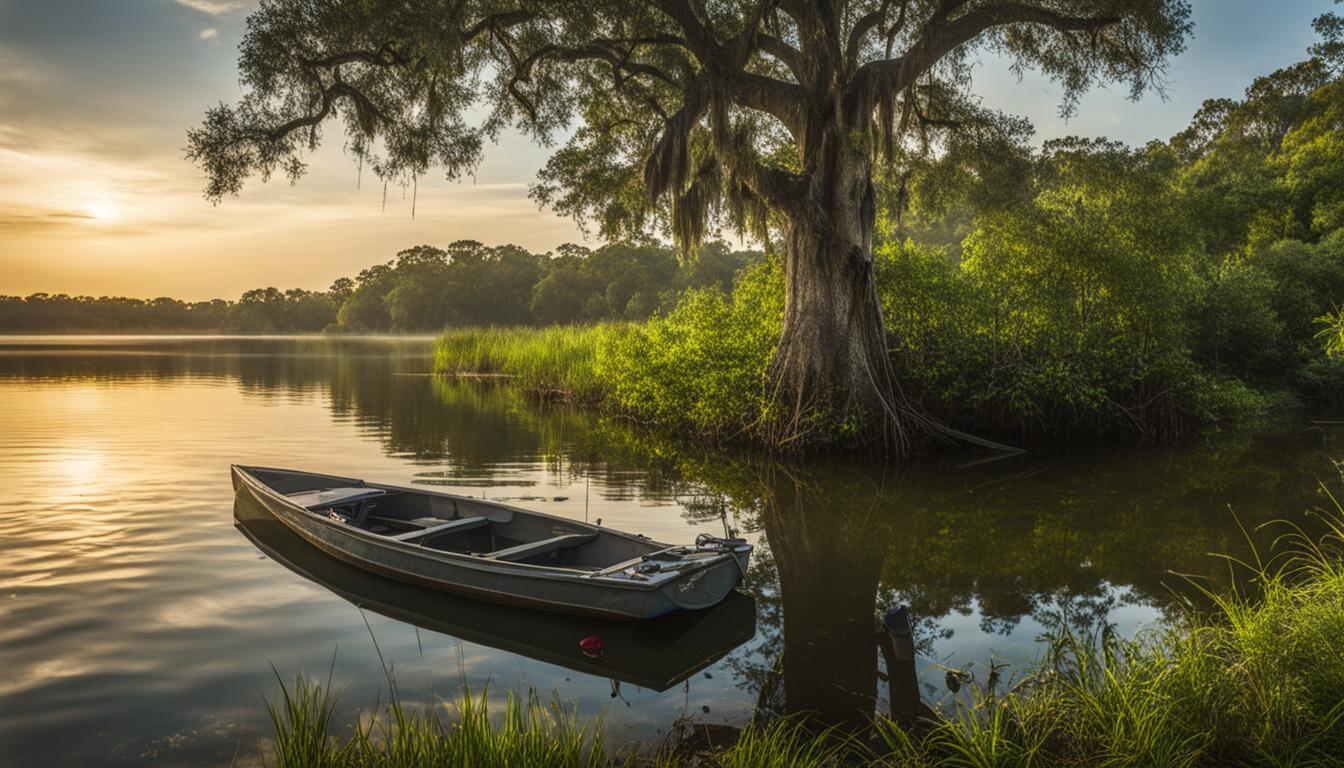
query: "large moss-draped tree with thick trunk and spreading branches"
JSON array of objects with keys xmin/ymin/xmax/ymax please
[{"xmin": 188, "ymin": 0, "xmax": 1189, "ymax": 449}]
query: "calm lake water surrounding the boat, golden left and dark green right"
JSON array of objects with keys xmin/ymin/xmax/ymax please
[{"xmin": 0, "ymin": 336, "xmax": 1344, "ymax": 765}]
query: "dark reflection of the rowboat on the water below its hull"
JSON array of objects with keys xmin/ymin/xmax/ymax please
[{"xmin": 234, "ymin": 494, "xmax": 755, "ymax": 691}]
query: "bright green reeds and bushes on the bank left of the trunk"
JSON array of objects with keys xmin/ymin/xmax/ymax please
[{"xmin": 434, "ymin": 261, "xmax": 784, "ymax": 437}]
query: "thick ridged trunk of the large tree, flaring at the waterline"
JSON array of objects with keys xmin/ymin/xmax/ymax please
[{"xmin": 767, "ymin": 139, "xmax": 918, "ymax": 453}]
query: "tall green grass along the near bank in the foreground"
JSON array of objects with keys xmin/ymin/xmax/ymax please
[{"xmin": 269, "ymin": 484, "xmax": 1344, "ymax": 768}]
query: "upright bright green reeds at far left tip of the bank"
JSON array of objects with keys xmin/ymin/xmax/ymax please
[{"xmin": 434, "ymin": 323, "xmax": 620, "ymax": 402}]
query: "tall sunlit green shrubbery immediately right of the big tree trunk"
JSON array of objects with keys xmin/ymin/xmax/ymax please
[{"xmin": 878, "ymin": 140, "xmax": 1241, "ymax": 438}]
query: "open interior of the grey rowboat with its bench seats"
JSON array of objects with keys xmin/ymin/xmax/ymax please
[{"xmin": 250, "ymin": 469, "xmax": 664, "ymax": 573}]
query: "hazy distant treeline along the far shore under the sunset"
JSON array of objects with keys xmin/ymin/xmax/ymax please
[{"xmin": 0, "ymin": 241, "xmax": 761, "ymax": 334}]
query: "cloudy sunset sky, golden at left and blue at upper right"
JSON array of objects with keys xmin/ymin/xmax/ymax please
[{"xmin": 0, "ymin": 0, "xmax": 1336, "ymax": 299}]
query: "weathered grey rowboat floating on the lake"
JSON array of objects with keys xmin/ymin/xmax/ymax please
[{"xmin": 230, "ymin": 465, "xmax": 751, "ymax": 620}]
